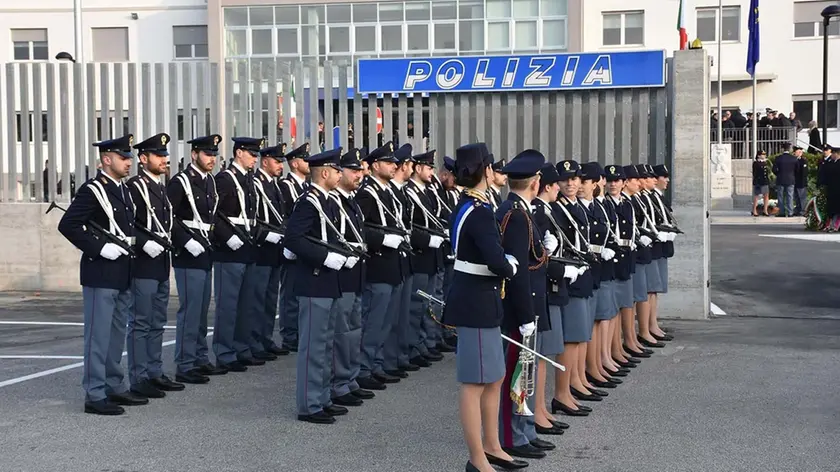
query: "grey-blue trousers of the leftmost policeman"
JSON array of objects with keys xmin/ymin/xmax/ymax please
[{"xmin": 82, "ymin": 287, "xmax": 134, "ymax": 401}]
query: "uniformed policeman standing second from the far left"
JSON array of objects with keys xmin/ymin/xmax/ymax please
[{"xmin": 127, "ymin": 133, "xmax": 184, "ymax": 398}]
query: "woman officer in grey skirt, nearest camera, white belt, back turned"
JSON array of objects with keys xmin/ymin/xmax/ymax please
[{"xmin": 443, "ymin": 143, "xmax": 528, "ymax": 472}]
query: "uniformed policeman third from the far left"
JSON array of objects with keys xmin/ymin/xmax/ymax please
[{"xmin": 166, "ymin": 134, "xmax": 227, "ymax": 384}]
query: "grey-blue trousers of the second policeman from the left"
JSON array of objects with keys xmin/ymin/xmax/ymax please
[{"xmin": 126, "ymin": 279, "xmax": 169, "ymax": 385}]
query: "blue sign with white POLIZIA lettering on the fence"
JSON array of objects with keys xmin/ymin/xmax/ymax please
[{"xmin": 356, "ymin": 50, "xmax": 665, "ymax": 94}]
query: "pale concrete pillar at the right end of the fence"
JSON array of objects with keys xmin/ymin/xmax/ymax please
[{"xmin": 659, "ymin": 49, "xmax": 711, "ymax": 319}]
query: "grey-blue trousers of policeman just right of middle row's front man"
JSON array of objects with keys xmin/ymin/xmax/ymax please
[{"xmin": 332, "ymin": 292, "xmax": 362, "ymax": 398}]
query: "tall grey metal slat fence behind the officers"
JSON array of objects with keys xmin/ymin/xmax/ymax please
[{"xmin": 0, "ymin": 57, "xmax": 672, "ymax": 202}]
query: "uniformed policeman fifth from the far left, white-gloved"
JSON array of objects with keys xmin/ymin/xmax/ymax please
[{"xmin": 249, "ymin": 143, "xmax": 289, "ymax": 361}]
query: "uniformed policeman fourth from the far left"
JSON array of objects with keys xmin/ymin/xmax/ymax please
[{"xmin": 213, "ymin": 138, "xmax": 265, "ymax": 372}]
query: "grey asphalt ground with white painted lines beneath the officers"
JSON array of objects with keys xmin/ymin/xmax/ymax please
[{"xmin": 0, "ymin": 226, "xmax": 840, "ymax": 472}]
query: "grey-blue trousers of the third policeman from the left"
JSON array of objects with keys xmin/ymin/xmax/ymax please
[{"xmin": 174, "ymin": 268, "xmax": 213, "ymax": 373}]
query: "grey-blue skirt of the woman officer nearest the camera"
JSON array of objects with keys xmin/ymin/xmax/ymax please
[{"xmin": 455, "ymin": 326, "xmax": 505, "ymax": 384}]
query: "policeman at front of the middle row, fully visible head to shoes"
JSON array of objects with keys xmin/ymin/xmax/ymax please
[{"xmin": 285, "ymin": 148, "xmax": 352, "ymax": 424}]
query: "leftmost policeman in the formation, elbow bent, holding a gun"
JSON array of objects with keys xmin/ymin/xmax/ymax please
[{"xmin": 58, "ymin": 134, "xmax": 149, "ymax": 415}]
